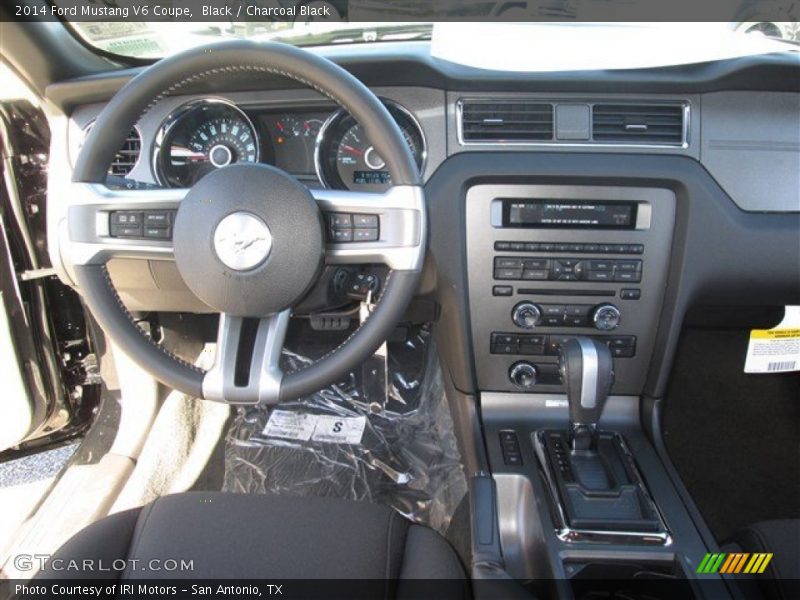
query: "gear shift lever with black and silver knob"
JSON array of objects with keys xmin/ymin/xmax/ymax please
[{"xmin": 559, "ymin": 336, "xmax": 614, "ymax": 452}]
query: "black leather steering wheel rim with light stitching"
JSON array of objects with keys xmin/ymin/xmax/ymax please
[{"xmin": 68, "ymin": 41, "xmax": 427, "ymax": 403}]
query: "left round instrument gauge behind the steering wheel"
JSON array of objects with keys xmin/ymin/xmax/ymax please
[{"xmin": 154, "ymin": 100, "xmax": 260, "ymax": 187}]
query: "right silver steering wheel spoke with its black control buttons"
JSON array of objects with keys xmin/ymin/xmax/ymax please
[{"xmin": 311, "ymin": 185, "xmax": 425, "ymax": 271}]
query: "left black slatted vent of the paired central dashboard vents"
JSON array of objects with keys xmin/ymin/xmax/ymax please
[{"xmin": 461, "ymin": 100, "xmax": 553, "ymax": 143}]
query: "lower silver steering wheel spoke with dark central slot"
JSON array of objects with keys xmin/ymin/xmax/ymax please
[{"xmin": 203, "ymin": 310, "xmax": 291, "ymax": 404}]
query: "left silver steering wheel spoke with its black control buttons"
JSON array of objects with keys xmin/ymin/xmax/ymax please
[{"xmin": 59, "ymin": 183, "xmax": 189, "ymax": 265}]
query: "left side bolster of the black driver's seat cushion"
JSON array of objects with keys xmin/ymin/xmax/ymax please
[{"xmin": 36, "ymin": 508, "xmax": 142, "ymax": 580}]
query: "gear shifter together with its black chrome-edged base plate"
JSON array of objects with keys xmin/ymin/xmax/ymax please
[{"xmin": 534, "ymin": 337, "xmax": 669, "ymax": 544}]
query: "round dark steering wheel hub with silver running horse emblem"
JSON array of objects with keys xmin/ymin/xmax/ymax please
[{"xmin": 173, "ymin": 163, "xmax": 324, "ymax": 317}]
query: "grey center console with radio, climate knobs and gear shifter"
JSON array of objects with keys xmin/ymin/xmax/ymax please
[{"xmin": 465, "ymin": 183, "xmax": 725, "ymax": 599}]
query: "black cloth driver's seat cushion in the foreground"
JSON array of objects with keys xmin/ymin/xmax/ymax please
[{"xmin": 39, "ymin": 492, "xmax": 468, "ymax": 598}]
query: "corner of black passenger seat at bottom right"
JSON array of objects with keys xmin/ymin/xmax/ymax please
[{"xmin": 722, "ymin": 519, "xmax": 800, "ymax": 600}]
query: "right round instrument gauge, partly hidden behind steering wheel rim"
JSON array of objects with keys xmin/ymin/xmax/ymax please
[{"xmin": 315, "ymin": 102, "xmax": 425, "ymax": 192}]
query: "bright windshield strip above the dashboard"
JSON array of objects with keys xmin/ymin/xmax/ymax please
[{"xmin": 72, "ymin": 21, "xmax": 800, "ymax": 62}]
